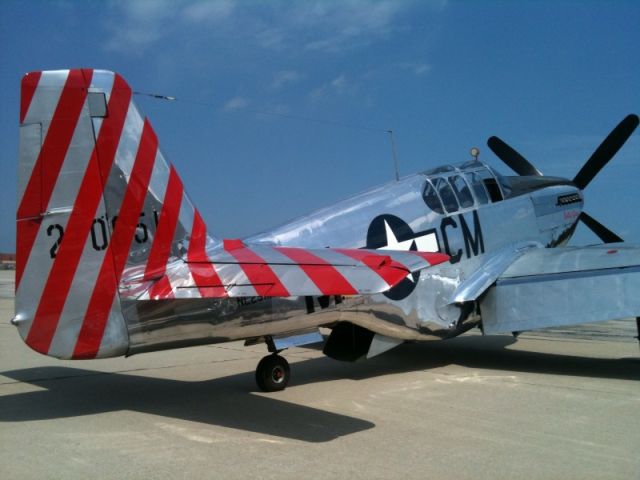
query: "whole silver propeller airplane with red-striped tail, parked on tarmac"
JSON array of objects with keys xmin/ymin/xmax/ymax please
[{"xmin": 12, "ymin": 69, "xmax": 640, "ymax": 391}]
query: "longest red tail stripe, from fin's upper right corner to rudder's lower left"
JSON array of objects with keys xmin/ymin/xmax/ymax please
[{"xmin": 26, "ymin": 75, "xmax": 131, "ymax": 354}]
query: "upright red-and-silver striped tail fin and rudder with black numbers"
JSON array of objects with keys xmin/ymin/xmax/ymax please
[{"xmin": 14, "ymin": 69, "xmax": 213, "ymax": 358}]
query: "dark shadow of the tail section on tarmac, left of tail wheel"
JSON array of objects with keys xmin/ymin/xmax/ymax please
[{"xmin": 0, "ymin": 367, "xmax": 375, "ymax": 442}]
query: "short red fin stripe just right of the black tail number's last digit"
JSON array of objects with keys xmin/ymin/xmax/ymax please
[{"xmin": 144, "ymin": 165, "xmax": 183, "ymax": 298}]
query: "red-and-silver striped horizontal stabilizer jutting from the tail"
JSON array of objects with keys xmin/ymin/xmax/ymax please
[{"xmin": 121, "ymin": 240, "xmax": 449, "ymax": 299}]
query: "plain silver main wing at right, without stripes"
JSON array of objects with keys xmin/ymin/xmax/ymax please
[{"xmin": 480, "ymin": 244, "xmax": 640, "ymax": 334}]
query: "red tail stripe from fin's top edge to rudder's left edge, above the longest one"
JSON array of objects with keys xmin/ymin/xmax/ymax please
[{"xmin": 16, "ymin": 70, "xmax": 92, "ymax": 290}]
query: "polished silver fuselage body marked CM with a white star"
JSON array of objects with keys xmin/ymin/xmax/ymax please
[{"xmin": 123, "ymin": 164, "xmax": 583, "ymax": 354}]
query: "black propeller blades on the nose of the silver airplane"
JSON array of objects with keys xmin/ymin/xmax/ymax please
[{"xmin": 487, "ymin": 114, "xmax": 640, "ymax": 243}]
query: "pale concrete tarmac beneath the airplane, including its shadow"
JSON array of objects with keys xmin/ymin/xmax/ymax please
[{"xmin": 0, "ymin": 272, "xmax": 640, "ymax": 479}]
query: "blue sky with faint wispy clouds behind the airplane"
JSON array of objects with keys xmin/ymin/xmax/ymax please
[{"xmin": 0, "ymin": 0, "xmax": 640, "ymax": 251}]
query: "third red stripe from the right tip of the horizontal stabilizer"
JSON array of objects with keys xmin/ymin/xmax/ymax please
[{"xmin": 275, "ymin": 247, "xmax": 358, "ymax": 295}]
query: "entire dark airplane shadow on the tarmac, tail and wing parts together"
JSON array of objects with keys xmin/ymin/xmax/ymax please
[{"xmin": 0, "ymin": 336, "xmax": 640, "ymax": 442}]
